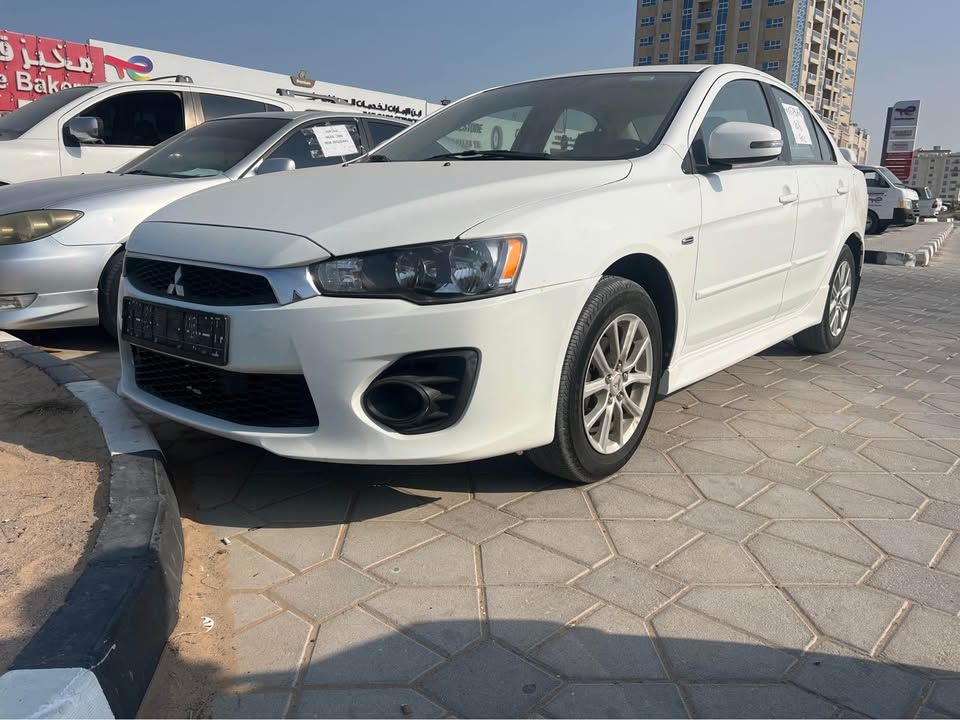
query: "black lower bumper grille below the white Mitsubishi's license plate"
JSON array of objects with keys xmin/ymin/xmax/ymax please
[{"xmin": 131, "ymin": 346, "xmax": 318, "ymax": 428}]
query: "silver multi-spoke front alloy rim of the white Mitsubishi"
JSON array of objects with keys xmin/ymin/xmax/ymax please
[{"xmin": 583, "ymin": 313, "xmax": 653, "ymax": 455}]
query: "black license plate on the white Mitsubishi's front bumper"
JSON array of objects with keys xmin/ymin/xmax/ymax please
[{"xmin": 120, "ymin": 298, "xmax": 229, "ymax": 365}]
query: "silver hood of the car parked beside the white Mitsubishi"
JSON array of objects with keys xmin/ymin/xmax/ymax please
[{"xmin": 0, "ymin": 173, "xmax": 211, "ymax": 215}]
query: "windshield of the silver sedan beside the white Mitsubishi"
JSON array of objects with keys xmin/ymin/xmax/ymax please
[{"xmin": 117, "ymin": 117, "xmax": 289, "ymax": 178}]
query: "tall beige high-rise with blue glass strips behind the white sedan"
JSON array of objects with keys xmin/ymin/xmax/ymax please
[{"xmin": 633, "ymin": 0, "xmax": 869, "ymax": 162}]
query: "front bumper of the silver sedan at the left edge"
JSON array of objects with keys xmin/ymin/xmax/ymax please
[{"xmin": 0, "ymin": 235, "xmax": 120, "ymax": 330}]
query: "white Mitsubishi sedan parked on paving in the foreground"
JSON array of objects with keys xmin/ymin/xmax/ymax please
[{"xmin": 120, "ymin": 65, "xmax": 867, "ymax": 481}]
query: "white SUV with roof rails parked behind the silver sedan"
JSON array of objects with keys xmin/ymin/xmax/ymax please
[{"xmin": 0, "ymin": 77, "xmax": 324, "ymax": 185}]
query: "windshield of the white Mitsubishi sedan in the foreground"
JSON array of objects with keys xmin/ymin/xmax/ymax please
[{"xmin": 369, "ymin": 72, "xmax": 696, "ymax": 162}]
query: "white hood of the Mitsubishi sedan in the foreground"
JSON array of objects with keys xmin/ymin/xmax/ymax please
[{"xmin": 148, "ymin": 160, "xmax": 631, "ymax": 255}]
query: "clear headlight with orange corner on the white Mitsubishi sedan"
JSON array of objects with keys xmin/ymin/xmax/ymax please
[{"xmin": 310, "ymin": 236, "xmax": 526, "ymax": 303}]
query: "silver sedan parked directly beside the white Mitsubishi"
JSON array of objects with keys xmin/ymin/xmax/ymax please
[{"xmin": 0, "ymin": 110, "xmax": 408, "ymax": 337}]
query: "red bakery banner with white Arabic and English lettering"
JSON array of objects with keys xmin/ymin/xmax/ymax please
[{"xmin": 0, "ymin": 30, "xmax": 106, "ymax": 113}]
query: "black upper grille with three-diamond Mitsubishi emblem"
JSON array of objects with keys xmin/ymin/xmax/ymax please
[{"xmin": 124, "ymin": 257, "xmax": 277, "ymax": 306}]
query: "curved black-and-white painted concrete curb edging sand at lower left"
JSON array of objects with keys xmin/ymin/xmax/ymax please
[{"xmin": 0, "ymin": 332, "xmax": 183, "ymax": 718}]
